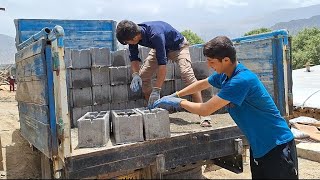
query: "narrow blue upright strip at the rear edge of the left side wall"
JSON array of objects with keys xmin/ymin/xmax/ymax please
[{"xmin": 45, "ymin": 45, "xmax": 58, "ymax": 156}]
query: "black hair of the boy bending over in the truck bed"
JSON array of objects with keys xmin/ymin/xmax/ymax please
[{"xmin": 116, "ymin": 20, "xmax": 140, "ymax": 45}]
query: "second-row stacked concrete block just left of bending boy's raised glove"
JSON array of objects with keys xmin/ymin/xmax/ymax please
[{"xmin": 109, "ymin": 66, "xmax": 129, "ymax": 86}]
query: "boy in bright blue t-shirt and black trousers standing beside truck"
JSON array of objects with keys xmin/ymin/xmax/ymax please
[{"xmin": 154, "ymin": 36, "xmax": 298, "ymax": 179}]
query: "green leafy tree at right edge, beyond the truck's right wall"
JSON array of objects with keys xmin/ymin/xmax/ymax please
[{"xmin": 292, "ymin": 28, "xmax": 320, "ymax": 69}]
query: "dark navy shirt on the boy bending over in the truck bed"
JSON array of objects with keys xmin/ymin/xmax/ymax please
[{"xmin": 129, "ymin": 21, "xmax": 184, "ymax": 65}]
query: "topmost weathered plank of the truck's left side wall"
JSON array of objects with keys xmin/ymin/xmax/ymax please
[{"xmin": 15, "ymin": 39, "xmax": 46, "ymax": 63}]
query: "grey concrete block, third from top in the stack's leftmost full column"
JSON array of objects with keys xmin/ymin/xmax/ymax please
[{"xmin": 72, "ymin": 87, "xmax": 92, "ymax": 107}]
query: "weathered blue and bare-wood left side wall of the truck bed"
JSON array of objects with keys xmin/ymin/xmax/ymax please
[{"xmin": 16, "ymin": 40, "xmax": 53, "ymax": 157}]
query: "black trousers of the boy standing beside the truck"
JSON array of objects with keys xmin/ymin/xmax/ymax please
[{"xmin": 250, "ymin": 140, "xmax": 298, "ymax": 179}]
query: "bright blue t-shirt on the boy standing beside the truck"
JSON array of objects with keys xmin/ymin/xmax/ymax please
[{"xmin": 208, "ymin": 64, "xmax": 294, "ymax": 158}]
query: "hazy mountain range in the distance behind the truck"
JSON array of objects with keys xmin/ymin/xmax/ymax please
[{"xmin": 0, "ymin": 4, "xmax": 320, "ymax": 64}]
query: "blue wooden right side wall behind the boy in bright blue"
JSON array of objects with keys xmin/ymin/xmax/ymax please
[{"xmin": 233, "ymin": 30, "xmax": 292, "ymax": 115}]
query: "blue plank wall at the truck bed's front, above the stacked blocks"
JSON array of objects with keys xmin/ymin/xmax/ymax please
[{"xmin": 14, "ymin": 19, "xmax": 117, "ymax": 51}]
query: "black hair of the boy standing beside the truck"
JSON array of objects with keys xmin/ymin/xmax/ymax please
[{"xmin": 203, "ymin": 36, "xmax": 237, "ymax": 63}]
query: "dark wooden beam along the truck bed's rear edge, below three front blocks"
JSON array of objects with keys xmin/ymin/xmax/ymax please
[{"xmin": 68, "ymin": 138, "xmax": 240, "ymax": 178}]
